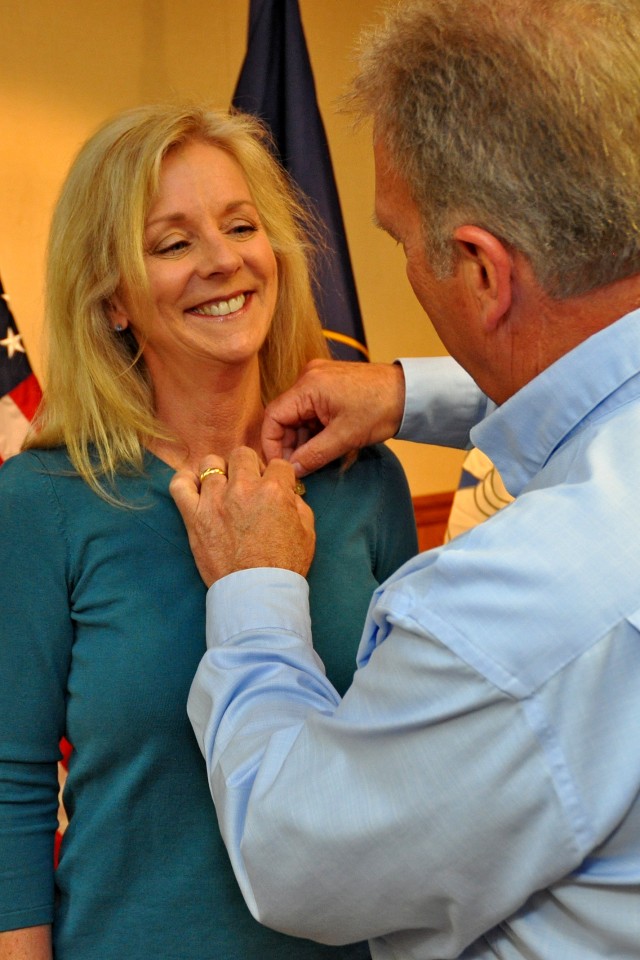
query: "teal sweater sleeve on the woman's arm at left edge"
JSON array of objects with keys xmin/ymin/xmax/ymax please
[{"xmin": 0, "ymin": 453, "xmax": 72, "ymax": 930}]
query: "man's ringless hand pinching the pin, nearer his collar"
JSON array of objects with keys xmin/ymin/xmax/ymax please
[{"xmin": 262, "ymin": 360, "xmax": 404, "ymax": 477}]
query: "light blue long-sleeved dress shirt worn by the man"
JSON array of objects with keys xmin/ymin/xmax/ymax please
[{"xmin": 189, "ymin": 312, "xmax": 640, "ymax": 960}]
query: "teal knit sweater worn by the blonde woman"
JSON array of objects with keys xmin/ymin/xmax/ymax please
[{"xmin": 0, "ymin": 447, "xmax": 417, "ymax": 960}]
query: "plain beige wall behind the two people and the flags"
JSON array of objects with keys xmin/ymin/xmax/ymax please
[{"xmin": 0, "ymin": 0, "xmax": 461, "ymax": 495}]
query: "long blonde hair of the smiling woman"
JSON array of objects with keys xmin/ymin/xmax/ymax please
[{"xmin": 25, "ymin": 104, "xmax": 329, "ymax": 496}]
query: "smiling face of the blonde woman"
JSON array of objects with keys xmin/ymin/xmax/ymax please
[{"xmin": 119, "ymin": 141, "xmax": 278, "ymax": 377}]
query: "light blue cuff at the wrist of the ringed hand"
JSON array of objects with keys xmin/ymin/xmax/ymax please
[{"xmin": 207, "ymin": 567, "xmax": 312, "ymax": 648}]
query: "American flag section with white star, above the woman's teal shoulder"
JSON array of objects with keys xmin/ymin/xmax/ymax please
[{"xmin": 0, "ymin": 281, "xmax": 42, "ymax": 464}]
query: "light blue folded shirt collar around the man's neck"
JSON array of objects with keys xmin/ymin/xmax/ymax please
[{"xmin": 471, "ymin": 310, "xmax": 640, "ymax": 496}]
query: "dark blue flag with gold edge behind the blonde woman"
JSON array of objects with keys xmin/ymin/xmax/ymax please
[{"xmin": 233, "ymin": 0, "xmax": 369, "ymax": 360}]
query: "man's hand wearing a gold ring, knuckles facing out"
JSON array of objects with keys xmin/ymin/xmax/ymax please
[{"xmin": 169, "ymin": 447, "xmax": 315, "ymax": 587}]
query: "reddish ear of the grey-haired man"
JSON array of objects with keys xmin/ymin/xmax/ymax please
[{"xmin": 453, "ymin": 224, "xmax": 513, "ymax": 331}]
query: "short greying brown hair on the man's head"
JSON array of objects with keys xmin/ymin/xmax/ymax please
[{"xmin": 348, "ymin": 0, "xmax": 640, "ymax": 298}]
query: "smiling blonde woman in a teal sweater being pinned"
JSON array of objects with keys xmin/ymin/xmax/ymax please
[{"xmin": 0, "ymin": 106, "xmax": 417, "ymax": 960}]
